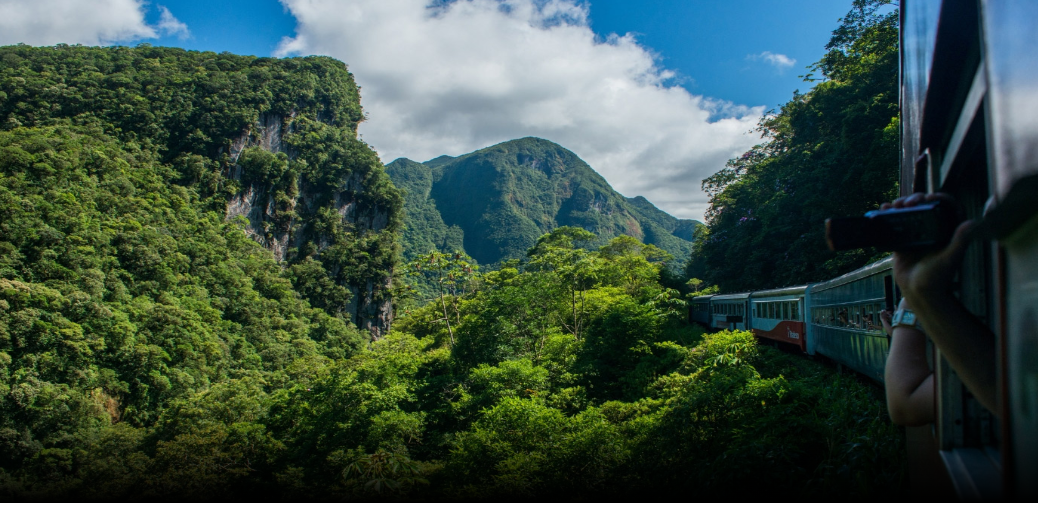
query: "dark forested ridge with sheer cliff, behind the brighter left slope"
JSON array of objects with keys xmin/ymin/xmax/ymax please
[{"xmin": 0, "ymin": 46, "xmax": 401, "ymax": 334}]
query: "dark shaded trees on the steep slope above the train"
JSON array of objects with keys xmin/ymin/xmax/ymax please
[{"xmin": 686, "ymin": 0, "xmax": 900, "ymax": 291}]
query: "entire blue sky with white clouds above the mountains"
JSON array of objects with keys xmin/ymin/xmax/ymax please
[{"xmin": 0, "ymin": 0, "xmax": 852, "ymax": 220}]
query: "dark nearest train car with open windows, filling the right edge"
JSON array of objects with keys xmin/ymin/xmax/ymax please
[{"xmin": 900, "ymin": 0, "xmax": 1038, "ymax": 502}]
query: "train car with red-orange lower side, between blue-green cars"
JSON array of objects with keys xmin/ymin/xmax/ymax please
[{"xmin": 749, "ymin": 286, "xmax": 810, "ymax": 352}]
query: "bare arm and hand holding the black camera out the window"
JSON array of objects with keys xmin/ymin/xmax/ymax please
[{"xmin": 882, "ymin": 193, "xmax": 999, "ymax": 415}]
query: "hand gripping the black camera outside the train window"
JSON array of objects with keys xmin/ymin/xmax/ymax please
[{"xmin": 879, "ymin": 192, "xmax": 976, "ymax": 299}]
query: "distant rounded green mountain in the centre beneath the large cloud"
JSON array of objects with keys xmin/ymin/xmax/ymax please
[{"xmin": 386, "ymin": 137, "xmax": 698, "ymax": 269}]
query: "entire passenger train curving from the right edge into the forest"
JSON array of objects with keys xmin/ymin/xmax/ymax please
[{"xmin": 689, "ymin": 0, "xmax": 1038, "ymax": 502}]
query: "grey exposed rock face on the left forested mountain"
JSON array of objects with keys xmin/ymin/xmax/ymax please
[{"xmin": 226, "ymin": 111, "xmax": 400, "ymax": 338}]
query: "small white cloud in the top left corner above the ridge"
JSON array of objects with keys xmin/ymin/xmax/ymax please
[{"xmin": 0, "ymin": 0, "xmax": 187, "ymax": 46}]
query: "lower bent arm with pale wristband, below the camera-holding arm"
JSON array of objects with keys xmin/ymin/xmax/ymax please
[{"xmin": 879, "ymin": 299, "xmax": 936, "ymax": 426}]
